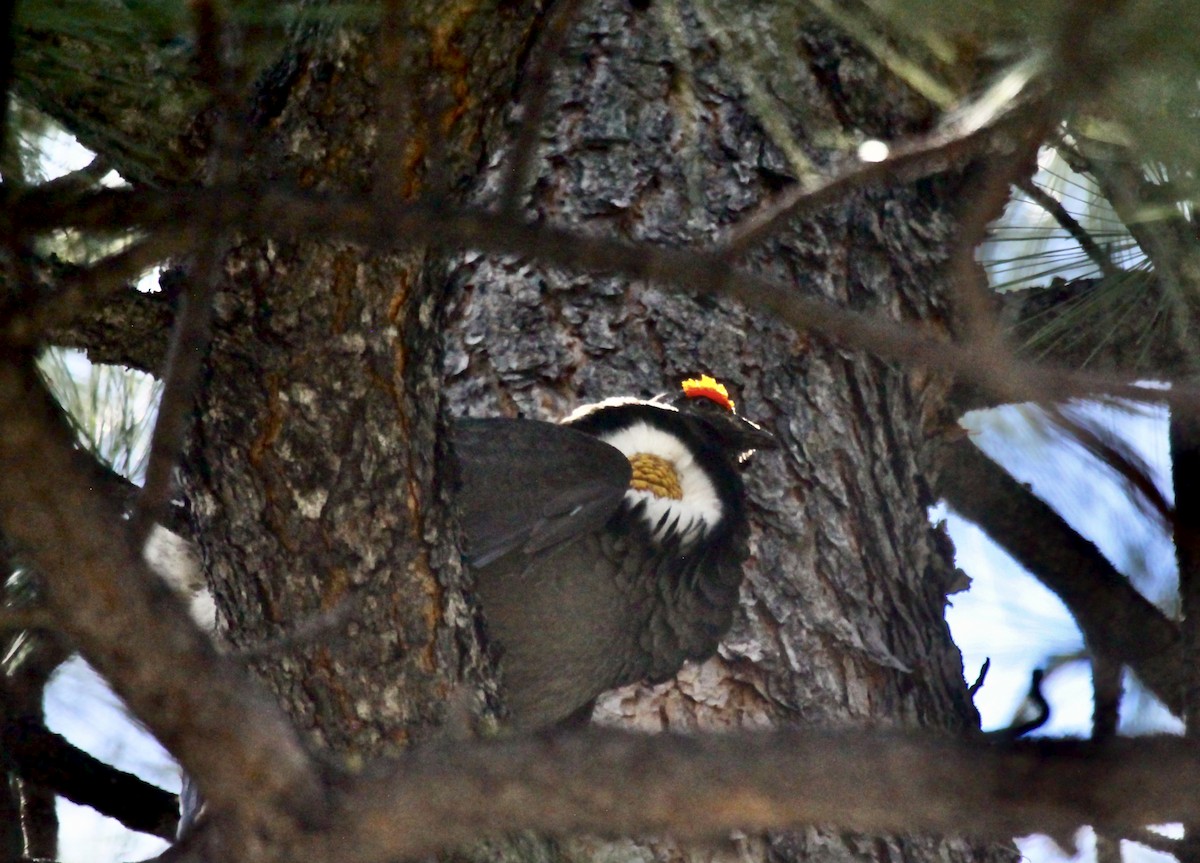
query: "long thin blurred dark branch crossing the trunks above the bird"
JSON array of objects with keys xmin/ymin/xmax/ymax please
[{"xmin": 8, "ymin": 188, "xmax": 1200, "ymax": 407}]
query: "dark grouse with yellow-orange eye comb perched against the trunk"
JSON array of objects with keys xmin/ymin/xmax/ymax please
[{"xmin": 452, "ymin": 376, "xmax": 775, "ymax": 729}]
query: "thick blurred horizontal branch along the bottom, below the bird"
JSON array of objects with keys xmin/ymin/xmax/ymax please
[{"xmin": 285, "ymin": 730, "xmax": 1200, "ymax": 863}]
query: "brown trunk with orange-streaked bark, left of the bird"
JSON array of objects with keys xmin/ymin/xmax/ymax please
[{"xmin": 185, "ymin": 4, "xmax": 534, "ymax": 755}]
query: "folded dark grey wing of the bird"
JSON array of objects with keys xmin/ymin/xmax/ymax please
[{"xmin": 451, "ymin": 419, "xmax": 632, "ymax": 567}]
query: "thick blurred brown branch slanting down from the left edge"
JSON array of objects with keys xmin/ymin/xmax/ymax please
[{"xmin": 0, "ymin": 348, "xmax": 317, "ymax": 830}]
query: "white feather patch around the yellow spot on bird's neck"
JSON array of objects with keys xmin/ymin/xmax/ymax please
[{"xmin": 600, "ymin": 422, "xmax": 722, "ymax": 546}]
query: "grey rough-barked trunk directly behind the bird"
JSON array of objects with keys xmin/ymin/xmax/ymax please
[{"xmin": 446, "ymin": 2, "xmax": 1007, "ymax": 861}]
